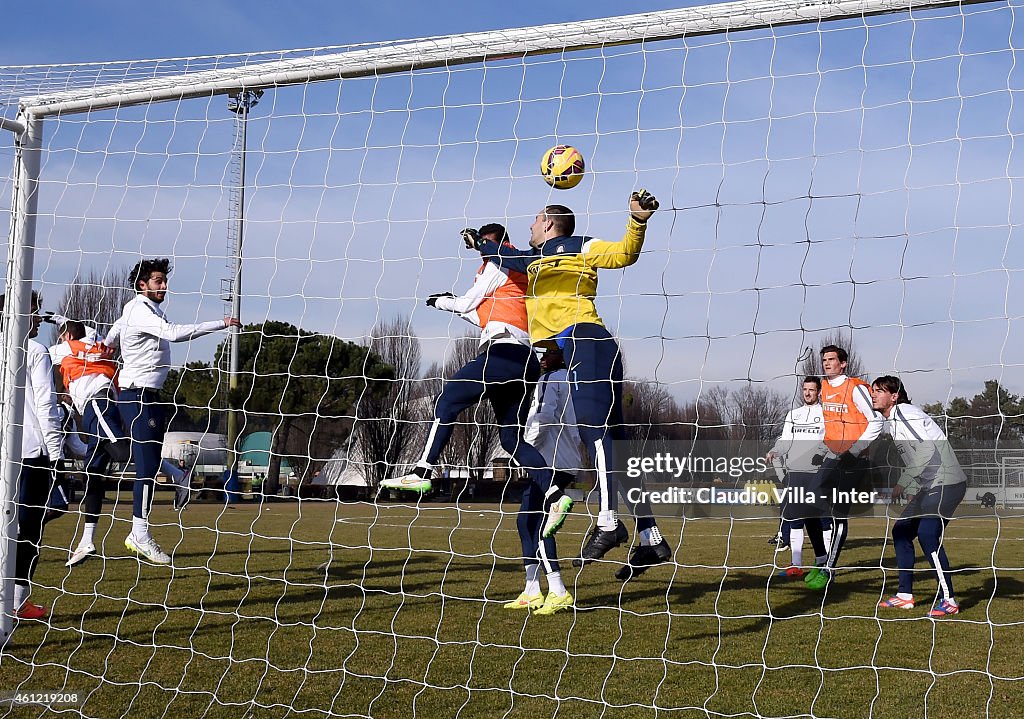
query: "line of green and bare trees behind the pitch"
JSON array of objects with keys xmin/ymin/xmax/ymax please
[{"xmin": 51, "ymin": 272, "xmax": 1024, "ymax": 492}]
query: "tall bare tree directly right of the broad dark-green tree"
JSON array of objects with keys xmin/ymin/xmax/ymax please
[{"xmin": 355, "ymin": 315, "xmax": 422, "ymax": 488}]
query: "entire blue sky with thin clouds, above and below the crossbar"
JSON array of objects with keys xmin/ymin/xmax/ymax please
[{"xmin": 0, "ymin": 2, "xmax": 1024, "ymax": 400}]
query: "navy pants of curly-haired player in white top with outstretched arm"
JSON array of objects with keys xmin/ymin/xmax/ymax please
[{"xmin": 118, "ymin": 389, "xmax": 167, "ymax": 518}]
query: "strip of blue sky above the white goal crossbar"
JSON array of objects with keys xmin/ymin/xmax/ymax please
[{"xmin": 0, "ymin": 0, "xmax": 699, "ymax": 65}]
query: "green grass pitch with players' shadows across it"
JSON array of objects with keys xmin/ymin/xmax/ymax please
[{"xmin": 0, "ymin": 497, "xmax": 1024, "ymax": 719}]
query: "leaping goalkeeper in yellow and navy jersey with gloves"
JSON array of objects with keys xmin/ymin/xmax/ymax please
[{"xmin": 466, "ymin": 189, "xmax": 672, "ymax": 579}]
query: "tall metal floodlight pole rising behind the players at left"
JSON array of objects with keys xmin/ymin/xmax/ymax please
[{"xmin": 224, "ymin": 90, "xmax": 263, "ymax": 476}]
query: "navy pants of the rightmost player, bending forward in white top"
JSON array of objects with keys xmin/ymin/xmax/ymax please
[{"xmin": 893, "ymin": 482, "xmax": 967, "ymax": 599}]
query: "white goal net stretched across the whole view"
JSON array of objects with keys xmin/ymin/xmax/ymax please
[{"xmin": 0, "ymin": 0, "xmax": 1024, "ymax": 719}]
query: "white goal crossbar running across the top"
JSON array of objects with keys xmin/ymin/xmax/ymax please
[{"xmin": 8, "ymin": 0, "xmax": 990, "ymax": 119}]
